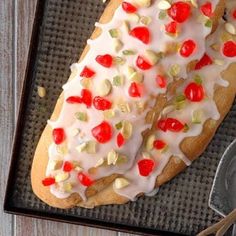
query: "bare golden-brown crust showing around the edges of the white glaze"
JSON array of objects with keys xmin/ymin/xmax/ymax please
[{"xmin": 31, "ymin": 0, "xmax": 236, "ymax": 208}]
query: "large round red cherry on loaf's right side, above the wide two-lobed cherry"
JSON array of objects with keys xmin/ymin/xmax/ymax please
[{"xmin": 184, "ymin": 82, "xmax": 205, "ymax": 102}]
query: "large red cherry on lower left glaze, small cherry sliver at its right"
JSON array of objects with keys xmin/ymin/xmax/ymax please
[{"xmin": 92, "ymin": 121, "xmax": 112, "ymax": 143}]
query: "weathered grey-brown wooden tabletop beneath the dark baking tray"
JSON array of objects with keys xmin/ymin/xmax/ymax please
[{"xmin": 0, "ymin": 0, "xmax": 136, "ymax": 236}]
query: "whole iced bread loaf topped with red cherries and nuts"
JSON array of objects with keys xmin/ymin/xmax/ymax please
[{"xmin": 31, "ymin": 0, "xmax": 236, "ymax": 208}]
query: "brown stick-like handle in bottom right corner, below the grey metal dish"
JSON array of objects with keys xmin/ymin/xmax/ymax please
[{"xmin": 197, "ymin": 209, "xmax": 236, "ymax": 236}]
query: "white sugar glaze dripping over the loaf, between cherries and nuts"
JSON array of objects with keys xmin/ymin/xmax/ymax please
[{"xmin": 42, "ymin": 0, "xmax": 236, "ymax": 200}]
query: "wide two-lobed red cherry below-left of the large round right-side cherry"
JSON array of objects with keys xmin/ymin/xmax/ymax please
[{"xmin": 157, "ymin": 118, "xmax": 184, "ymax": 132}]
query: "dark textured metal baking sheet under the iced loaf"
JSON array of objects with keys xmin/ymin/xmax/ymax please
[{"xmin": 4, "ymin": 0, "xmax": 236, "ymax": 235}]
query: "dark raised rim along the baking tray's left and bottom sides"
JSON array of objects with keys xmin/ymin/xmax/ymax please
[{"xmin": 3, "ymin": 0, "xmax": 183, "ymax": 236}]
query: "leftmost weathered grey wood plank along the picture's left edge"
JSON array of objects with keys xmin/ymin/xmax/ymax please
[{"xmin": 0, "ymin": 0, "xmax": 14, "ymax": 236}]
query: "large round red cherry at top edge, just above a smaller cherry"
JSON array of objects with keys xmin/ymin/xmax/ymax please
[{"xmin": 168, "ymin": 1, "xmax": 191, "ymax": 23}]
